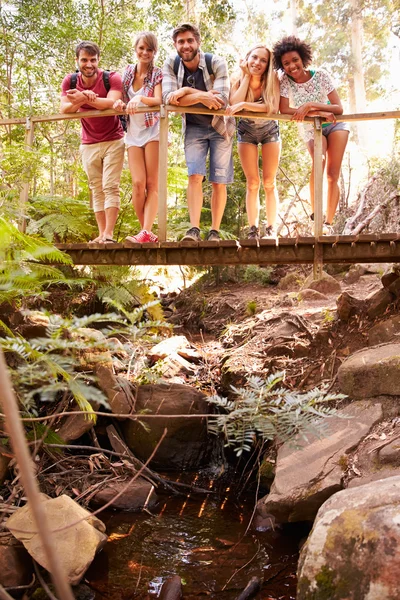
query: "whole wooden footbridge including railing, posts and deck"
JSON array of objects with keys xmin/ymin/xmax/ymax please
[{"xmin": 0, "ymin": 105, "xmax": 400, "ymax": 277}]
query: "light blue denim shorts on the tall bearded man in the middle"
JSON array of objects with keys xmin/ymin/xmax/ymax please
[{"xmin": 185, "ymin": 125, "xmax": 233, "ymax": 183}]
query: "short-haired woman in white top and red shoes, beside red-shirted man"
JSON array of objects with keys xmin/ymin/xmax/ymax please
[{"xmin": 114, "ymin": 32, "xmax": 162, "ymax": 243}]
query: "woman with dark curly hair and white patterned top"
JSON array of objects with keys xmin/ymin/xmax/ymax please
[{"xmin": 273, "ymin": 35, "xmax": 350, "ymax": 233}]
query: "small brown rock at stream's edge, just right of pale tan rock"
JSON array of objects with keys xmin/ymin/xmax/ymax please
[{"xmin": 92, "ymin": 477, "xmax": 158, "ymax": 511}]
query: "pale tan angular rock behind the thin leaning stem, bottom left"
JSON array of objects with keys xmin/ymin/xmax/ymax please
[{"xmin": 6, "ymin": 494, "xmax": 107, "ymax": 585}]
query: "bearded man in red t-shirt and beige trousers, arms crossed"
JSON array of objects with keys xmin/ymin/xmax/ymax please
[{"xmin": 61, "ymin": 41, "xmax": 125, "ymax": 243}]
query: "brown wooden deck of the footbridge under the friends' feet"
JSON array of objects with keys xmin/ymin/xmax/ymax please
[{"xmin": 57, "ymin": 233, "xmax": 400, "ymax": 266}]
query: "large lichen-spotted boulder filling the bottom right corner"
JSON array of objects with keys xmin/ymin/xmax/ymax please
[{"xmin": 296, "ymin": 476, "xmax": 400, "ymax": 600}]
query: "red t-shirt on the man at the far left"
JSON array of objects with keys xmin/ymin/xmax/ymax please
[{"xmin": 61, "ymin": 69, "xmax": 124, "ymax": 144}]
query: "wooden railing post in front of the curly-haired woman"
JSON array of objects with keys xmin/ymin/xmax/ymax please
[{"xmin": 313, "ymin": 117, "xmax": 323, "ymax": 279}]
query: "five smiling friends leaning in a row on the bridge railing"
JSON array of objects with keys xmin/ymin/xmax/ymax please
[{"xmin": 61, "ymin": 23, "xmax": 349, "ymax": 243}]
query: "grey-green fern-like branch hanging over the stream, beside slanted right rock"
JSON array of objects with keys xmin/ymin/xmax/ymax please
[{"xmin": 208, "ymin": 372, "xmax": 345, "ymax": 456}]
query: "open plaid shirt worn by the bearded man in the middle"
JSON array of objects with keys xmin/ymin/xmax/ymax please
[{"xmin": 163, "ymin": 50, "xmax": 235, "ymax": 138}]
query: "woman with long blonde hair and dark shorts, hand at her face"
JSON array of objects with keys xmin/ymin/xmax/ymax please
[{"xmin": 227, "ymin": 44, "xmax": 281, "ymax": 239}]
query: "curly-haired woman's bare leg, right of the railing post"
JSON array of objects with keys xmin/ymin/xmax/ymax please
[{"xmin": 326, "ymin": 131, "xmax": 349, "ymax": 223}]
